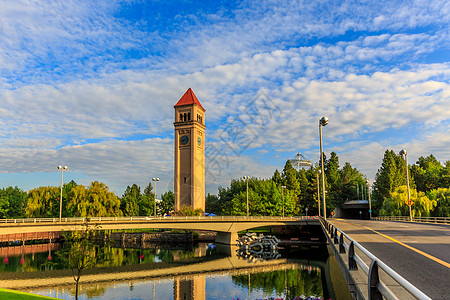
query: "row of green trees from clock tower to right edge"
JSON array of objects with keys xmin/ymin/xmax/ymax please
[{"xmin": 206, "ymin": 150, "xmax": 450, "ymax": 217}]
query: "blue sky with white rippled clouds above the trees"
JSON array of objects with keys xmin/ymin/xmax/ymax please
[{"xmin": 0, "ymin": 0, "xmax": 450, "ymax": 196}]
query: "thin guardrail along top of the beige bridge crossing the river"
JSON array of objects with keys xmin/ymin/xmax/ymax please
[{"xmin": 0, "ymin": 216, "xmax": 318, "ymax": 225}]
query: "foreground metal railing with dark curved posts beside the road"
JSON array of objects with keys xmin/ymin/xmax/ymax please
[{"xmin": 321, "ymin": 219, "xmax": 431, "ymax": 300}]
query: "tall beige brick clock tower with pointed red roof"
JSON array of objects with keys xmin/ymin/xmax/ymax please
[{"xmin": 173, "ymin": 88, "xmax": 205, "ymax": 212}]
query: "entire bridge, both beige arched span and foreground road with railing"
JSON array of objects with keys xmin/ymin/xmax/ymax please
[{"xmin": 0, "ymin": 217, "xmax": 450, "ymax": 299}]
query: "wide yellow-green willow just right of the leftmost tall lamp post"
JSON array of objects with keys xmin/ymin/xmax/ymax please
[{"xmin": 68, "ymin": 181, "xmax": 122, "ymax": 217}]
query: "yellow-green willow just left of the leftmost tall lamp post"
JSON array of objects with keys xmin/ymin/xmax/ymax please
[{"xmin": 25, "ymin": 186, "xmax": 61, "ymax": 218}]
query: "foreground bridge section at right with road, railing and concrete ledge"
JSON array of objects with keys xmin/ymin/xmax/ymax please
[{"xmin": 323, "ymin": 219, "xmax": 450, "ymax": 300}]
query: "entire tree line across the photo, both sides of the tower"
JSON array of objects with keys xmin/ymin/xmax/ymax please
[{"xmin": 0, "ymin": 150, "xmax": 450, "ymax": 218}]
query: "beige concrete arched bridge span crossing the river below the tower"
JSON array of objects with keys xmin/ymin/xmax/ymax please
[{"xmin": 0, "ymin": 216, "xmax": 320, "ymax": 245}]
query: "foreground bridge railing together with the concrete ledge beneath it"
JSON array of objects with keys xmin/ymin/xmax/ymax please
[{"xmin": 321, "ymin": 219, "xmax": 431, "ymax": 300}]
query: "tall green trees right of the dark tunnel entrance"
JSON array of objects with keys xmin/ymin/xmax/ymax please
[{"xmin": 372, "ymin": 150, "xmax": 450, "ymax": 217}]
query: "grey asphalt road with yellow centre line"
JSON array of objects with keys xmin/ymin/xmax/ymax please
[{"xmin": 328, "ymin": 219, "xmax": 450, "ymax": 299}]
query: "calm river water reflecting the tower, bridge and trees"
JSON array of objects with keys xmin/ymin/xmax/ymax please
[{"xmin": 0, "ymin": 238, "xmax": 351, "ymax": 300}]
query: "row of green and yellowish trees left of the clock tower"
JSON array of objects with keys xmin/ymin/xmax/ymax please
[{"xmin": 0, "ymin": 181, "xmax": 174, "ymax": 218}]
